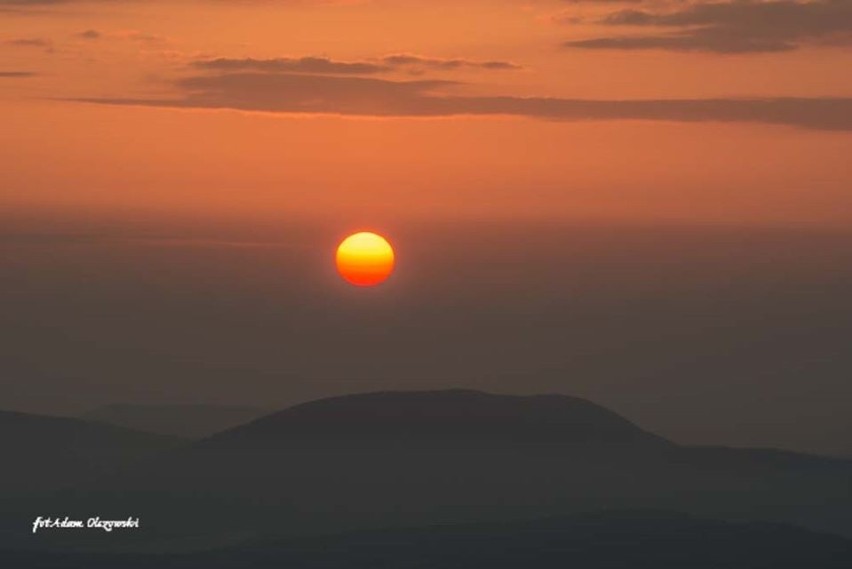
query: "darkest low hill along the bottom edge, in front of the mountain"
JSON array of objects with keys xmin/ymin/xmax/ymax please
[{"xmin": 6, "ymin": 511, "xmax": 852, "ymax": 569}]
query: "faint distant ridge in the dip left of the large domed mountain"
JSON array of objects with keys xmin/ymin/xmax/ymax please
[{"xmin": 80, "ymin": 403, "xmax": 269, "ymax": 439}]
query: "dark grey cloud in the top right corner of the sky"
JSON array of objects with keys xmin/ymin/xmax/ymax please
[{"xmin": 563, "ymin": 0, "xmax": 852, "ymax": 53}]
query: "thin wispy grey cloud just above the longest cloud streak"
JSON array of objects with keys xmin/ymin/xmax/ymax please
[{"xmin": 191, "ymin": 54, "xmax": 521, "ymax": 75}]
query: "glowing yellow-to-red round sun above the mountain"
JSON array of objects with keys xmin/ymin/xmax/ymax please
[{"xmin": 336, "ymin": 231, "xmax": 395, "ymax": 287}]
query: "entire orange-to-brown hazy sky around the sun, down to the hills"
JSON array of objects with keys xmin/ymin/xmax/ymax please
[{"xmin": 0, "ymin": 0, "xmax": 852, "ymax": 453}]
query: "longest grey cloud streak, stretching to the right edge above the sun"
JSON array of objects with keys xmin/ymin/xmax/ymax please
[{"xmin": 77, "ymin": 73, "xmax": 852, "ymax": 131}]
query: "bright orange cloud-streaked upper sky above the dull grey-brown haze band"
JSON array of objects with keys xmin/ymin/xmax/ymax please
[{"xmin": 0, "ymin": 0, "xmax": 852, "ymax": 227}]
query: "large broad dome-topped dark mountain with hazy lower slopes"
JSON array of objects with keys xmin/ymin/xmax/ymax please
[{"xmin": 6, "ymin": 390, "xmax": 852, "ymax": 549}]
